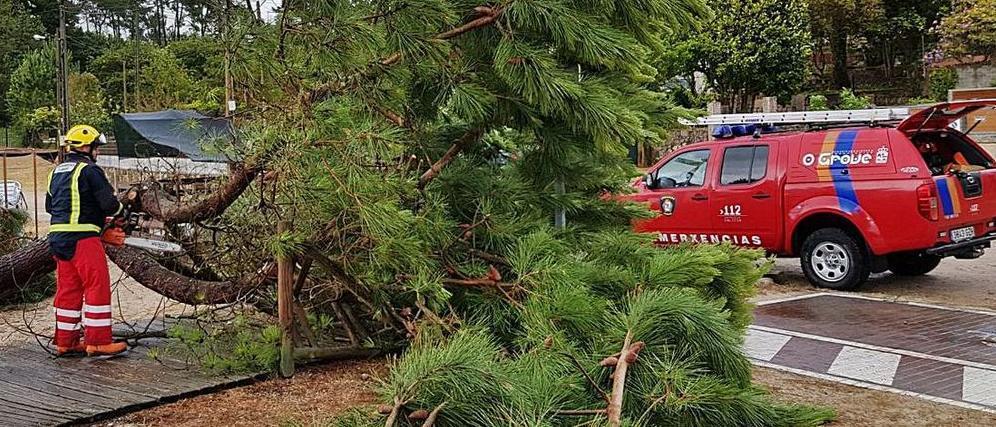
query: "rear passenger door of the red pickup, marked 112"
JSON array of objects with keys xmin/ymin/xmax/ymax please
[{"xmin": 709, "ymin": 144, "xmax": 783, "ymax": 248}]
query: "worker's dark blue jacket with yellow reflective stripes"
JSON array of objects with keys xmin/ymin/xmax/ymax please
[{"xmin": 45, "ymin": 152, "xmax": 124, "ymax": 261}]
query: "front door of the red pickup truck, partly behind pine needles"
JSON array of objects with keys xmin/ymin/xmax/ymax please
[{"xmin": 632, "ymin": 148, "xmax": 714, "ymax": 244}]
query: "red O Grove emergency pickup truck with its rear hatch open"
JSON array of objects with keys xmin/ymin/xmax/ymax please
[{"xmin": 625, "ymin": 100, "xmax": 996, "ymax": 289}]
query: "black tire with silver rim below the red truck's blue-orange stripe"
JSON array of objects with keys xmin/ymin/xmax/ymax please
[{"xmin": 800, "ymin": 228, "xmax": 871, "ymax": 291}]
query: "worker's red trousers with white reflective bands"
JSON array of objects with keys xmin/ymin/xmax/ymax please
[{"xmin": 55, "ymin": 237, "xmax": 111, "ymax": 347}]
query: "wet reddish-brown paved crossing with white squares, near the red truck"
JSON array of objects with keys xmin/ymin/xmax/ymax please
[{"xmin": 744, "ymin": 293, "xmax": 996, "ymax": 413}]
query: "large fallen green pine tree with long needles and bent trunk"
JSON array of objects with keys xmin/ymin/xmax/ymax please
[{"xmin": 0, "ymin": 0, "xmax": 830, "ymax": 426}]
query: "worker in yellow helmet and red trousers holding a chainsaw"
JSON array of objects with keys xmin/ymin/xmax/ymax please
[{"xmin": 45, "ymin": 125, "xmax": 128, "ymax": 356}]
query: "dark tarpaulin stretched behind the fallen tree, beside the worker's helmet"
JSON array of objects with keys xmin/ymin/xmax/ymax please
[{"xmin": 114, "ymin": 110, "xmax": 234, "ymax": 162}]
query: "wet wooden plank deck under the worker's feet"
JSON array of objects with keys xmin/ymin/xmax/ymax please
[{"xmin": 0, "ymin": 343, "xmax": 254, "ymax": 427}]
